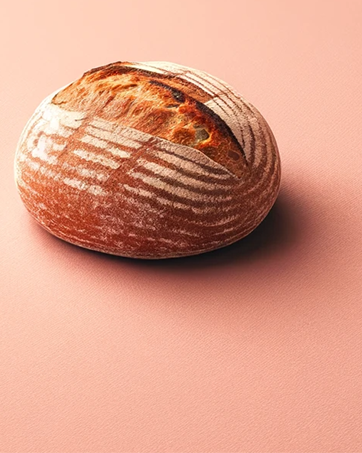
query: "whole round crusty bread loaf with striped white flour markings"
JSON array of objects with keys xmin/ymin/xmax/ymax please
[{"xmin": 15, "ymin": 62, "xmax": 280, "ymax": 259}]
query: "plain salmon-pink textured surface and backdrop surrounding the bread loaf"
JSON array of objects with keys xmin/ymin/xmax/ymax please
[{"xmin": 0, "ymin": 0, "xmax": 362, "ymax": 453}]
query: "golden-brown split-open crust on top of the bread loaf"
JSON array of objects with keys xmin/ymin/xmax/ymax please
[{"xmin": 52, "ymin": 62, "xmax": 248, "ymax": 178}]
